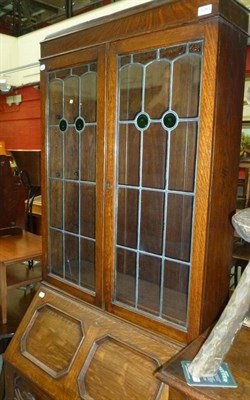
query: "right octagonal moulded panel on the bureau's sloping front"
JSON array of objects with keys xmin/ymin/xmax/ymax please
[{"xmin": 78, "ymin": 335, "xmax": 162, "ymax": 400}]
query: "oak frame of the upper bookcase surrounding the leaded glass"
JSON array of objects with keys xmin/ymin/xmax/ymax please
[{"xmin": 38, "ymin": 0, "xmax": 247, "ymax": 342}]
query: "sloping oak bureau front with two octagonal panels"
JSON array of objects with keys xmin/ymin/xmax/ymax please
[{"xmin": 5, "ymin": 283, "xmax": 182, "ymax": 400}]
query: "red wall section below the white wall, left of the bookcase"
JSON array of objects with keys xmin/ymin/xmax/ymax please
[{"xmin": 0, "ymin": 86, "xmax": 41, "ymax": 150}]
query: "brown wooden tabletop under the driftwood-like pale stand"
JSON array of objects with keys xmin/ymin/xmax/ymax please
[{"xmin": 156, "ymin": 326, "xmax": 250, "ymax": 400}]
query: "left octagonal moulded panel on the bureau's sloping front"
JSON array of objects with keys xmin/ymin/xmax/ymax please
[{"xmin": 21, "ymin": 304, "xmax": 84, "ymax": 378}]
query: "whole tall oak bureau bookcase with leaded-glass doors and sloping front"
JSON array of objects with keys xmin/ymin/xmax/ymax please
[{"xmin": 3, "ymin": 0, "xmax": 248, "ymax": 399}]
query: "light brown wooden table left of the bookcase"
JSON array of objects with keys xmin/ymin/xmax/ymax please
[{"xmin": 0, "ymin": 231, "xmax": 42, "ymax": 324}]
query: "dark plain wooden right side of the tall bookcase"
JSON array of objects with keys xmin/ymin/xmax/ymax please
[{"xmin": 201, "ymin": 23, "xmax": 246, "ymax": 332}]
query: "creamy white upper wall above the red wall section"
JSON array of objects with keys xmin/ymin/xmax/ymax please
[{"xmin": 0, "ymin": 0, "xmax": 153, "ymax": 86}]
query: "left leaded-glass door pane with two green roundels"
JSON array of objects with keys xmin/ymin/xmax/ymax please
[{"xmin": 44, "ymin": 47, "xmax": 102, "ymax": 304}]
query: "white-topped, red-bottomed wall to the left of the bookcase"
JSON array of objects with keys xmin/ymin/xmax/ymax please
[{"xmin": 0, "ymin": 0, "xmax": 152, "ymax": 150}]
